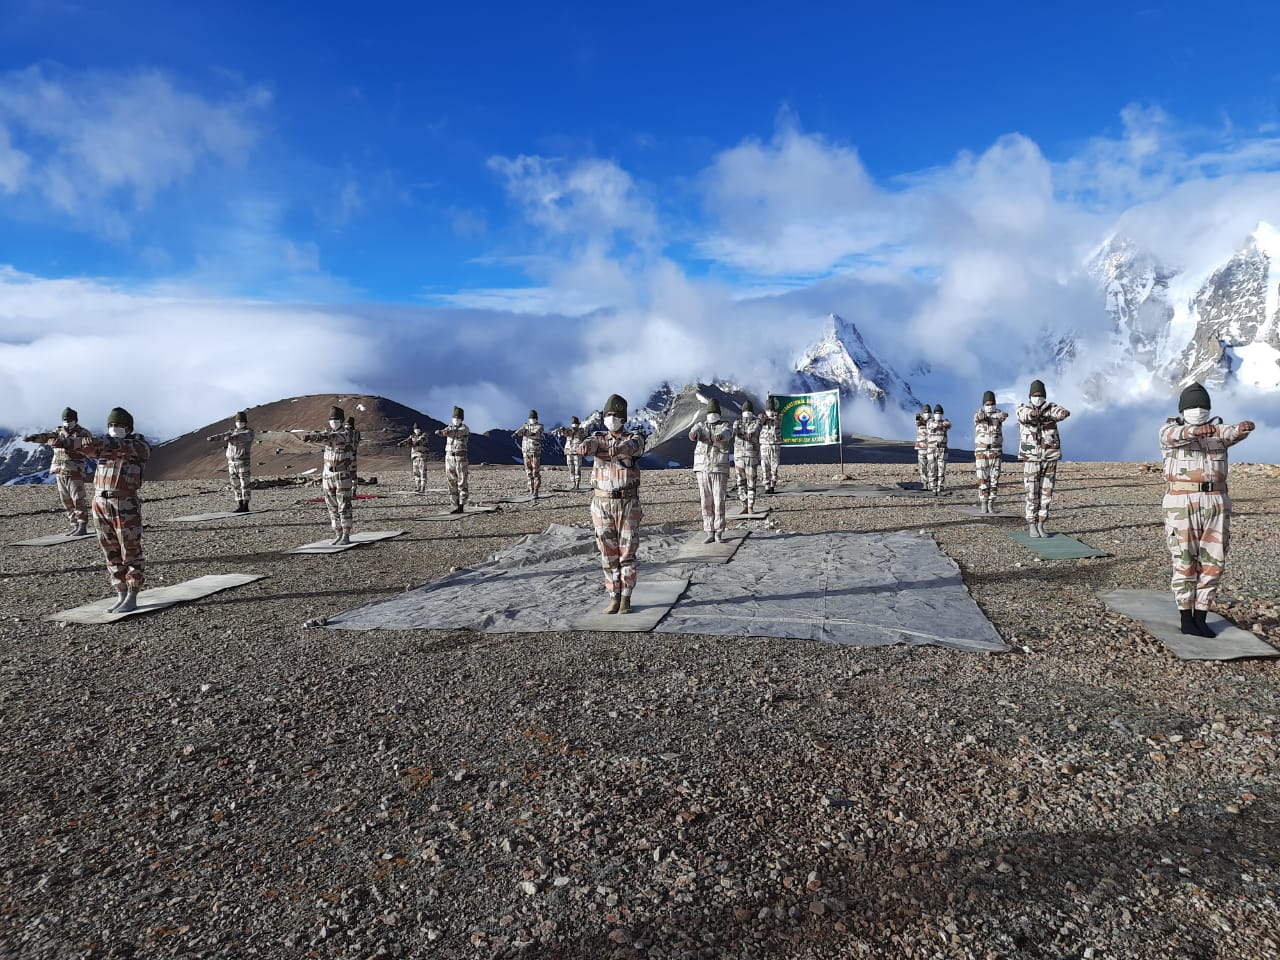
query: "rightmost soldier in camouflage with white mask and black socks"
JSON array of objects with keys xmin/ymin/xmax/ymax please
[{"xmin": 1160, "ymin": 383, "xmax": 1253, "ymax": 636}]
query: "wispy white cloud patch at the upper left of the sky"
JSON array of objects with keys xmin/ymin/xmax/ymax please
[{"xmin": 0, "ymin": 67, "xmax": 270, "ymax": 232}]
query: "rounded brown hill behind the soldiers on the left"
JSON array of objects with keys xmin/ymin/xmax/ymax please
[{"xmin": 147, "ymin": 394, "xmax": 518, "ymax": 480}]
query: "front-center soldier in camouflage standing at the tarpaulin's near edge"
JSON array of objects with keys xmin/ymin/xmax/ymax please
[{"xmin": 582, "ymin": 393, "xmax": 645, "ymax": 613}]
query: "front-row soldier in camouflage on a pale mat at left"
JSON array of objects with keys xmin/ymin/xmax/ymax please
[{"xmin": 52, "ymin": 407, "xmax": 151, "ymax": 613}]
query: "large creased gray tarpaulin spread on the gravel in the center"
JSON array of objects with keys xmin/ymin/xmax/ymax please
[{"xmin": 328, "ymin": 524, "xmax": 1009, "ymax": 653}]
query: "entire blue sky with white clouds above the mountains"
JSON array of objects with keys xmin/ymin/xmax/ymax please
[{"xmin": 0, "ymin": 0, "xmax": 1280, "ymax": 455}]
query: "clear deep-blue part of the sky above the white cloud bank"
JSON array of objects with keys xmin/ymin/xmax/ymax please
[{"xmin": 10, "ymin": 0, "xmax": 1280, "ymax": 302}]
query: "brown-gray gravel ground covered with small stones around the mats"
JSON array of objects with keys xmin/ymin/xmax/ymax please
[{"xmin": 0, "ymin": 463, "xmax": 1280, "ymax": 960}]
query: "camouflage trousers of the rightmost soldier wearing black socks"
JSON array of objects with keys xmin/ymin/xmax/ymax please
[{"xmin": 1161, "ymin": 493, "xmax": 1231, "ymax": 611}]
